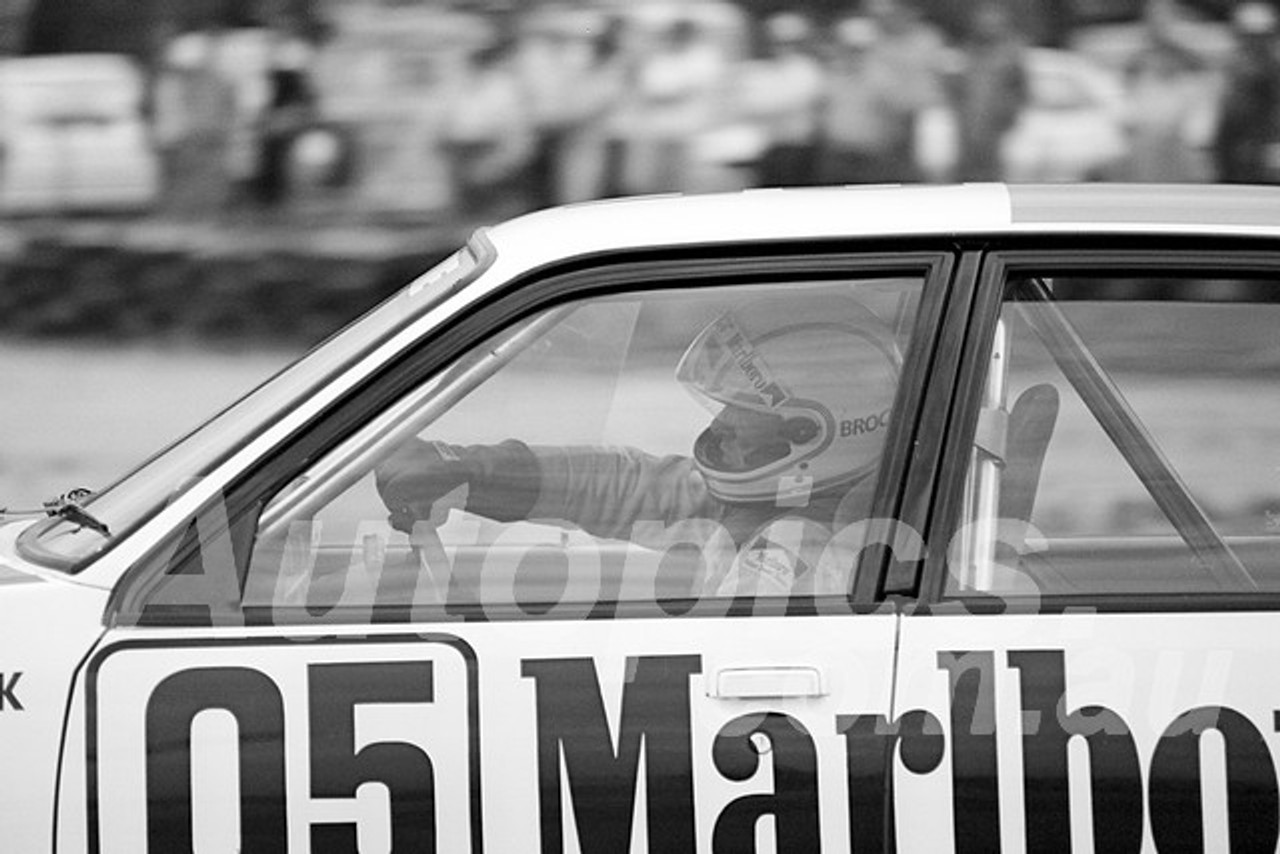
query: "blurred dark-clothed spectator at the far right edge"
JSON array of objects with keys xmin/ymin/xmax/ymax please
[{"xmin": 1213, "ymin": 1, "xmax": 1280, "ymax": 183}]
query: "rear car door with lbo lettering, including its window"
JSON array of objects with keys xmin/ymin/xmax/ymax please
[{"xmin": 892, "ymin": 239, "xmax": 1280, "ymax": 851}]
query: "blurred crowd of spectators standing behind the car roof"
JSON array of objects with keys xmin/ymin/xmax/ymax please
[{"xmin": 151, "ymin": 0, "xmax": 1280, "ymax": 222}]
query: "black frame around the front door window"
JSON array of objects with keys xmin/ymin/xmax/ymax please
[{"xmin": 104, "ymin": 238, "xmax": 956, "ymax": 627}]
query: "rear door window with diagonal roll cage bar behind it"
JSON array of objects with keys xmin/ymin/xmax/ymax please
[{"xmin": 948, "ymin": 275, "xmax": 1280, "ymax": 595}]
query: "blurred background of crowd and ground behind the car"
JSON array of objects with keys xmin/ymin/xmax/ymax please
[{"xmin": 0, "ymin": 0, "xmax": 1280, "ymax": 508}]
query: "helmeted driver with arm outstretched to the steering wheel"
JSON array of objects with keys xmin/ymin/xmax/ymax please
[{"xmin": 376, "ymin": 293, "xmax": 900, "ymax": 595}]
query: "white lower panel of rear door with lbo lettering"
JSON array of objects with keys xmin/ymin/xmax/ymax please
[{"xmin": 895, "ymin": 609, "xmax": 1277, "ymax": 851}]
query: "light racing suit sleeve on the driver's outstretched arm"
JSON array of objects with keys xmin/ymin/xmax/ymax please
[{"xmin": 519, "ymin": 446, "xmax": 723, "ymax": 539}]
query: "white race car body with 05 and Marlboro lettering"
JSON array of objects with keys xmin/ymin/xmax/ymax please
[{"xmin": 0, "ymin": 184, "xmax": 1280, "ymax": 851}]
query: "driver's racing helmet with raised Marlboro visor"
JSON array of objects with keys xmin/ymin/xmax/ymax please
[{"xmin": 676, "ymin": 293, "xmax": 901, "ymax": 506}]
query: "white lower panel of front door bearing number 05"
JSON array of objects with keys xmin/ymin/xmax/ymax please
[{"xmin": 64, "ymin": 615, "xmax": 896, "ymax": 851}]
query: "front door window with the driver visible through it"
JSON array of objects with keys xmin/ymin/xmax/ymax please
[{"xmin": 243, "ymin": 275, "xmax": 923, "ymax": 621}]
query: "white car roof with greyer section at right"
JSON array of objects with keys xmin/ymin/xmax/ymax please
[{"xmin": 486, "ymin": 183, "xmax": 1280, "ymax": 275}]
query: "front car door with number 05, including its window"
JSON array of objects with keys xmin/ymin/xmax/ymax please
[{"xmin": 59, "ymin": 247, "xmax": 952, "ymax": 851}]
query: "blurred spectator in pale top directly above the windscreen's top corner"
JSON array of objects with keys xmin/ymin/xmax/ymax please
[{"xmin": 442, "ymin": 40, "xmax": 534, "ymax": 218}]
